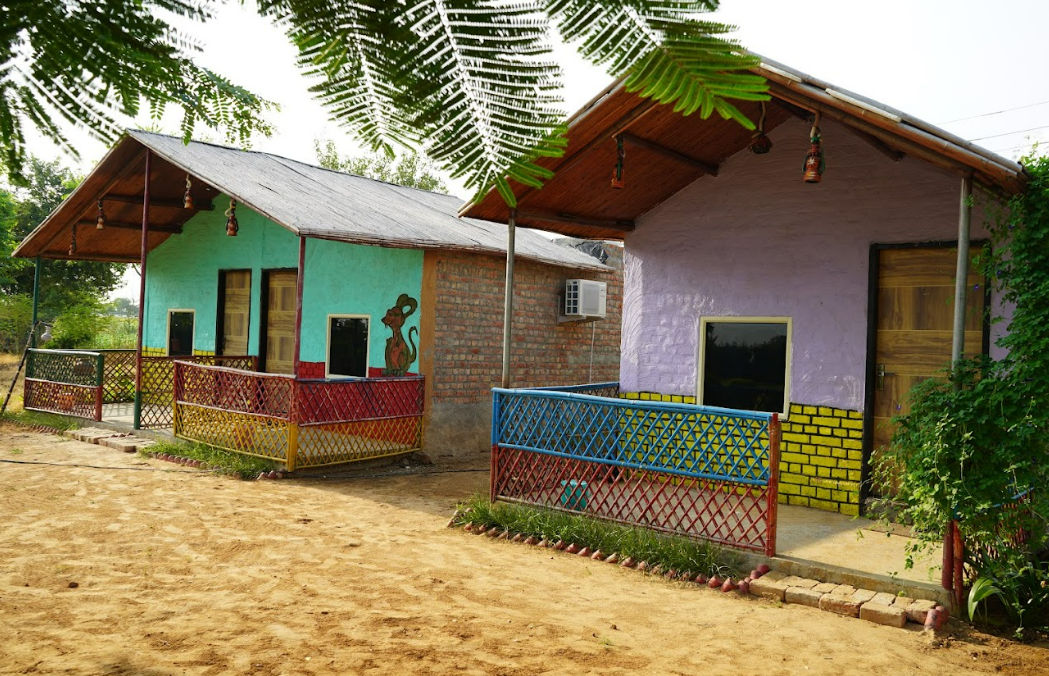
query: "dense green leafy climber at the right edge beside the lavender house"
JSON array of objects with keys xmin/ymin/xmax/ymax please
[{"xmin": 878, "ymin": 154, "xmax": 1049, "ymax": 627}]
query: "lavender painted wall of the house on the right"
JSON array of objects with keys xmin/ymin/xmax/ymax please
[{"xmin": 620, "ymin": 115, "xmax": 997, "ymax": 409}]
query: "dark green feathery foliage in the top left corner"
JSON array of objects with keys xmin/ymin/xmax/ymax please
[{"xmin": 0, "ymin": 0, "xmax": 271, "ymax": 184}]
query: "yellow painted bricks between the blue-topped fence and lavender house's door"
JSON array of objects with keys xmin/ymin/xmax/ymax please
[{"xmin": 779, "ymin": 403, "xmax": 863, "ymax": 515}]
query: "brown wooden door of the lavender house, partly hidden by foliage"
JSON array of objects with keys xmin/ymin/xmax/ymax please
[{"xmin": 872, "ymin": 245, "xmax": 986, "ymax": 494}]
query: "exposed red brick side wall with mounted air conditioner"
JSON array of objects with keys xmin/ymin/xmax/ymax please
[{"xmin": 427, "ymin": 249, "xmax": 623, "ymax": 403}]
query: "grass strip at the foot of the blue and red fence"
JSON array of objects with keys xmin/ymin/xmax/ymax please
[{"xmin": 454, "ymin": 495, "xmax": 742, "ymax": 577}]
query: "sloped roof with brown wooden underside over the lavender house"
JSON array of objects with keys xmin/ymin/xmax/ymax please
[{"xmin": 459, "ymin": 55, "xmax": 1026, "ymax": 239}]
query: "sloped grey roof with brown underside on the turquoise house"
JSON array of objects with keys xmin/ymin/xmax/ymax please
[{"xmin": 14, "ymin": 130, "xmax": 606, "ymax": 270}]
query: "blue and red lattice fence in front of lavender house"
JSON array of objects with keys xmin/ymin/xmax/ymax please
[{"xmin": 491, "ymin": 383, "xmax": 779, "ymax": 556}]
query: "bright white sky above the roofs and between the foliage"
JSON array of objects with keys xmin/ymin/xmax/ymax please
[{"xmin": 22, "ymin": 0, "xmax": 1049, "ymax": 295}]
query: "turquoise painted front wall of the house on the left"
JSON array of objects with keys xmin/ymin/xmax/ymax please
[{"xmin": 143, "ymin": 196, "xmax": 423, "ymax": 371}]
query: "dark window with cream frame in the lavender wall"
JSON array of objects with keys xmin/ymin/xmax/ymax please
[{"xmin": 698, "ymin": 317, "xmax": 791, "ymax": 413}]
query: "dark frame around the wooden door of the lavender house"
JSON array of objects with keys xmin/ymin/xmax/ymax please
[{"xmin": 859, "ymin": 238, "xmax": 991, "ymax": 514}]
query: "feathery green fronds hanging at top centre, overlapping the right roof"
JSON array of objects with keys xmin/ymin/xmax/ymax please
[{"xmin": 259, "ymin": 0, "xmax": 767, "ymax": 205}]
